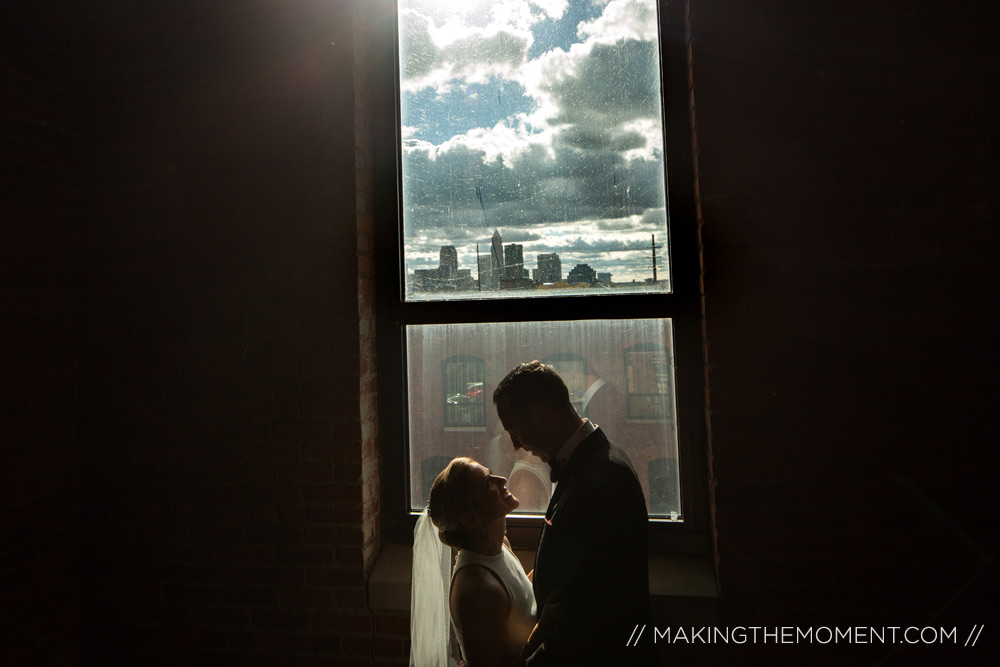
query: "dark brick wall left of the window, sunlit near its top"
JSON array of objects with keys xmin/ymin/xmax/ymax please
[{"xmin": 79, "ymin": 0, "xmax": 378, "ymax": 665}]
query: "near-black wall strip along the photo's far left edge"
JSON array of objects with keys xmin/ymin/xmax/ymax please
[{"xmin": 0, "ymin": 0, "xmax": 80, "ymax": 665}]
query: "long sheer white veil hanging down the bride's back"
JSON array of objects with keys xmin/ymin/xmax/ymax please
[{"xmin": 410, "ymin": 508, "xmax": 456, "ymax": 667}]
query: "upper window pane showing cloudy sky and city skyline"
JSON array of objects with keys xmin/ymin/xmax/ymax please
[{"xmin": 399, "ymin": 0, "xmax": 670, "ymax": 300}]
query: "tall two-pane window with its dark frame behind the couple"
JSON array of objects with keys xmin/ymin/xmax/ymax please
[{"xmin": 374, "ymin": 0, "xmax": 707, "ymax": 548}]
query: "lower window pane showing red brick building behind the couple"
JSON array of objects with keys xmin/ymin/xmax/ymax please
[{"xmin": 406, "ymin": 319, "xmax": 683, "ymax": 521}]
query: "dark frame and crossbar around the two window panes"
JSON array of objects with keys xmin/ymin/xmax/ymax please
[{"xmin": 370, "ymin": 0, "xmax": 711, "ymax": 555}]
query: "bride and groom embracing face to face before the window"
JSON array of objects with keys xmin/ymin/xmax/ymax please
[{"xmin": 411, "ymin": 361, "xmax": 656, "ymax": 667}]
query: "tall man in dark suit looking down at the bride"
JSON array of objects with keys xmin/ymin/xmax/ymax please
[{"xmin": 493, "ymin": 361, "xmax": 656, "ymax": 667}]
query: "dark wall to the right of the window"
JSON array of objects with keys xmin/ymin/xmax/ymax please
[{"xmin": 691, "ymin": 1, "xmax": 1000, "ymax": 664}]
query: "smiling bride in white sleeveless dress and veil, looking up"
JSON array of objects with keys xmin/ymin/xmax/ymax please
[{"xmin": 410, "ymin": 457, "xmax": 548, "ymax": 667}]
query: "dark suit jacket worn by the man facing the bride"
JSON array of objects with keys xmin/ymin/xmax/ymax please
[{"xmin": 527, "ymin": 428, "xmax": 657, "ymax": 667}]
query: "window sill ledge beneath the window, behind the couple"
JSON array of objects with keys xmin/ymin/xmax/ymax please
[{"xmin": 368, "ymin": 544, "xmax": 719, "ymax": 611}]
